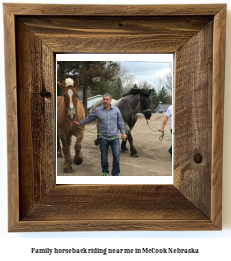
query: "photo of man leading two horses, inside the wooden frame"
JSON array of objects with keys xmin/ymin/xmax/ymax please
[{"xmin": 56, "ymin": 54, "xmax": 174, "ymax": 182}]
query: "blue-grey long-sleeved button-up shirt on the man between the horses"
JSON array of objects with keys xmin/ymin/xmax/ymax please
[{"xmin": 80, "ymin": 105, "xmax": 125, "ymax": 140}]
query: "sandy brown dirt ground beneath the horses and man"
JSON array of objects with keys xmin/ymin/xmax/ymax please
[{"xmin": 57, "ymin": 113, "xmax": 172, "ymax": 176}]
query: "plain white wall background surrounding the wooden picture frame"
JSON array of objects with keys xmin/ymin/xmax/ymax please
[{"xmin": 0, "ymin": 0, "xmax": 231, "ymax": 260}]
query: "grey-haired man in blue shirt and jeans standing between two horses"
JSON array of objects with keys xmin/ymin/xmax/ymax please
[{"xmin": 74, "ymin": 93, "xmax": 127, "ymax": 176}]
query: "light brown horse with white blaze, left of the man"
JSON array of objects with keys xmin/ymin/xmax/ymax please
[{"xmin": 57, "ymin": 78, "xmax": 85, "ymax": 173}]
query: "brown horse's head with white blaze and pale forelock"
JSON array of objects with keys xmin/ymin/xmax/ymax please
[{"xmin": 58, "ymin": 78, "xmax": 79, "ymax": 121}]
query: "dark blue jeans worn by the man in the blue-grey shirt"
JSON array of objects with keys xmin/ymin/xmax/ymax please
[{"xmin": 99, "ymin": 138, "xmax": 120, "ymax": 176}]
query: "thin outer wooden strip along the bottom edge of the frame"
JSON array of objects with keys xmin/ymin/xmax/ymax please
[{"xmin": 10, "ymin": 220, "xmax": 219, "ymax": 232}]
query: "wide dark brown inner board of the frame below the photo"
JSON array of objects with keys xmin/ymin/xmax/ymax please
[{"xmin": 23, "ymin": 185, "xmax": 208, "ymax": 221}]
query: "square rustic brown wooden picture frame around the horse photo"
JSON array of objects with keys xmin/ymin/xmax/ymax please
[{"xmin": 3, "ymin": 3, "xmax": 227, "ymax": 232}]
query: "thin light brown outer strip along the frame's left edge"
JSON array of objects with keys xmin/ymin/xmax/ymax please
[{"xmin": 3, "ymin": 5, "xmax": 19, "ymax": 229}]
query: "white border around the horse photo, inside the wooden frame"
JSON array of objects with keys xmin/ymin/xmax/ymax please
[{"xmin": 56, "ymin": 53, "xmax": 174, "ymax": 185}]
